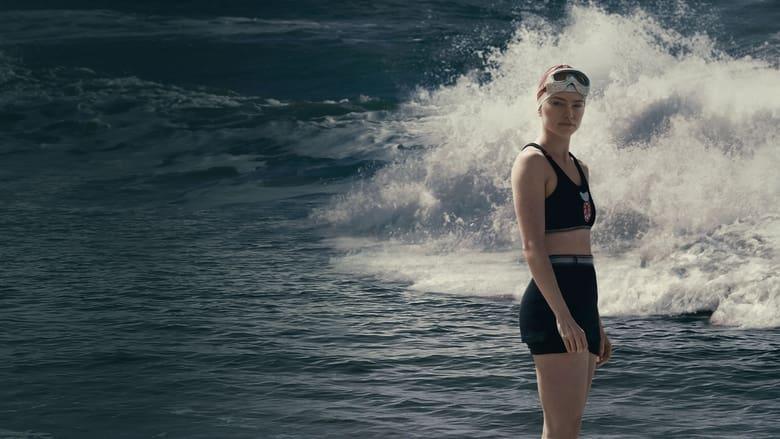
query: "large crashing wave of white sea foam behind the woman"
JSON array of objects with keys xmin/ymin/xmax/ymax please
[{"xmin": 316, "ymin": 6, "xmax": 780, "ymax": 327}]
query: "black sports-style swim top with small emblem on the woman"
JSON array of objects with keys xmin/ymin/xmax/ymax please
[{"xmin": 523, "ymin": 143, "xmax": 596, "ymax": 233}]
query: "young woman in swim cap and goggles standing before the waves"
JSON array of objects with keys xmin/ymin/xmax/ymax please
[{"xmin": 512, "ymin": 64, "xmax": 612, "ymax": 439}]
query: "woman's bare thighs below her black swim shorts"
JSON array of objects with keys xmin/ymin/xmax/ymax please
[{"xmin": 533, "ymin": 352, "xmax": 596, "ymax": 439}]
